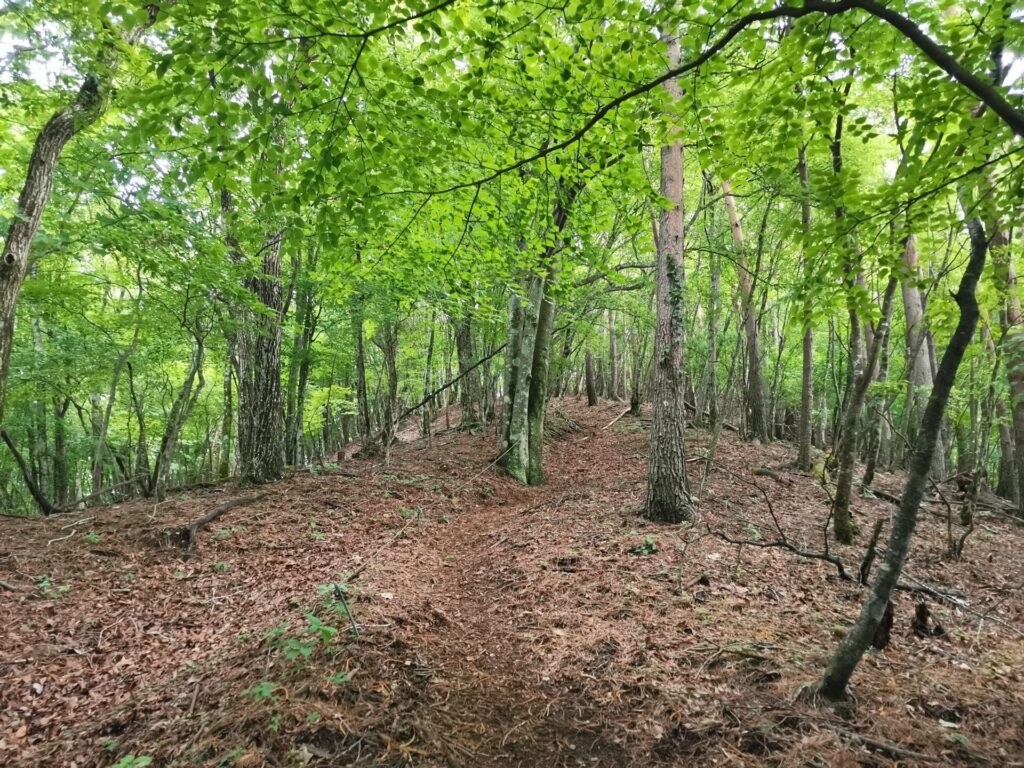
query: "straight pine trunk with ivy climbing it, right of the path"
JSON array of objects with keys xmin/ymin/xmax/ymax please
[{"xmin": 643, "ymin": 36, "xmax": 696, "ymax": 523}]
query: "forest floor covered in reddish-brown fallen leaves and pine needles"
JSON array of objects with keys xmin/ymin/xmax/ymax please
[{"xmin": 0, "ymin": 402, "xmax": 1024, "ymax": 768}]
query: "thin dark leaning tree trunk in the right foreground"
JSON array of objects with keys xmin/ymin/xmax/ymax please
[{"xmin": 818, "ymin": 219, "xmax": 988, "ymax": 700}]
